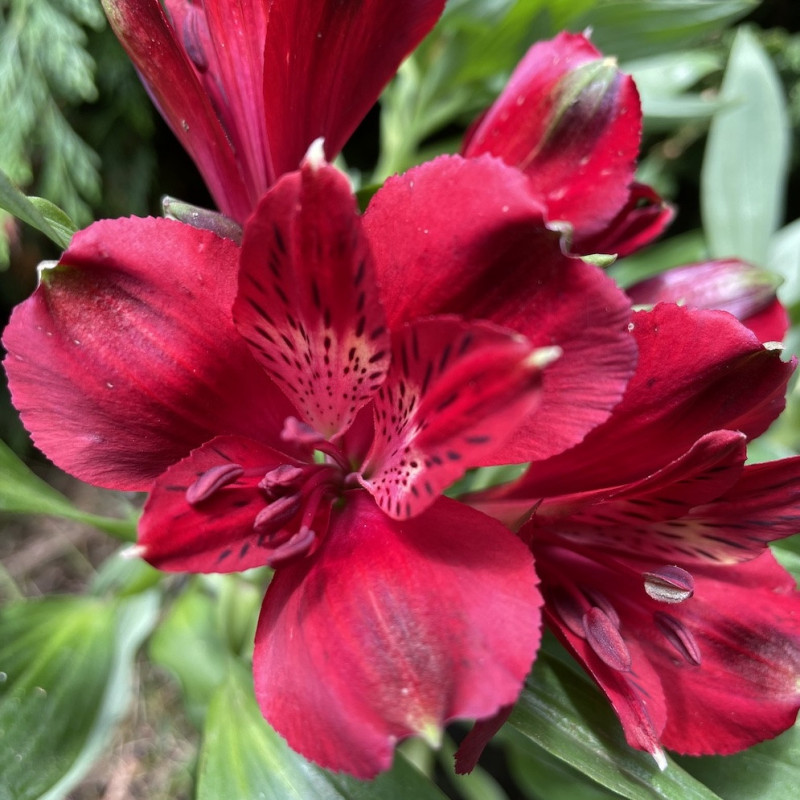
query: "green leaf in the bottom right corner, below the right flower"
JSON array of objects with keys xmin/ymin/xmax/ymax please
[{"xmin": 678, "ymin": 725, "xmax": 800, "ymax": 800}]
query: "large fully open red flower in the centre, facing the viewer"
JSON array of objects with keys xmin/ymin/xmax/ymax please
[{"xmin": 4, "ymin": 148, "xmax": 634, "ymax": 777}]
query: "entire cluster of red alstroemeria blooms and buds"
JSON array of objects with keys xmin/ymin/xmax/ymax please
[{"xmin": 4, "ymin": 0, "xmax": 800, "ymax": 777}]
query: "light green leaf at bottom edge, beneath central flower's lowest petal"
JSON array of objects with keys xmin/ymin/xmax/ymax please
[{"xmin": 196, "ymin": 665, "xmax": 444, "ymax": 800}]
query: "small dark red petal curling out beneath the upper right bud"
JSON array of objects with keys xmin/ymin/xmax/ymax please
[{"xmin": 571, "ymin": 182, "xmax": 675, "ymax": 258}]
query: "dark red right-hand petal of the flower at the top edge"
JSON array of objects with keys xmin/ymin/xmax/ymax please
[{"xmin": 264, "ymin": 0, "xmax": 444, "ymax": 175}]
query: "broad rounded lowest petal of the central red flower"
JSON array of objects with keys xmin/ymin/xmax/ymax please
[{"xmin": 253, "ymin": 491, "xmax": 540, "ymax": 778}]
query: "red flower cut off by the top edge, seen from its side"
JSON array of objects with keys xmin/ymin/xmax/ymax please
[{"xmin": 103, "ymin": 0, "xmax": 444, "ymax": 223}]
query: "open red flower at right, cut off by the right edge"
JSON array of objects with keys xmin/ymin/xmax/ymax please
[{"xmin": 460, "ymin": 304, "xmax": 800, "ymax": 769}]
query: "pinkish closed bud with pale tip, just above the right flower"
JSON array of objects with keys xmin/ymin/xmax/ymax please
[{"xmin": 626, "ymin": 258, "xmax": 789, "ymax": 342}]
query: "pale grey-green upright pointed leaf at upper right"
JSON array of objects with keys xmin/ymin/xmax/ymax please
[{"xmin": 700, "ymin": 28, "xmax": 789, "ymax": 266}]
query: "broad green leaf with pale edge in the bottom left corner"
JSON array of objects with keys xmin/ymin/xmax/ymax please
[{"xmin": 0, "ymin": 594, "xmax": 158, "ymax": 800}]
